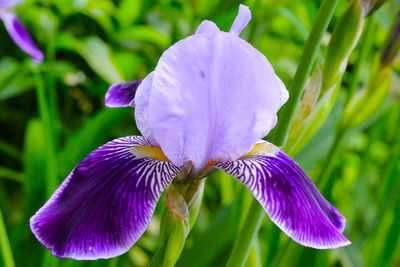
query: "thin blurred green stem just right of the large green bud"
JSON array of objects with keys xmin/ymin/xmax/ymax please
[{"xmin": 346, "ymin": 15, "xmax": 375, "ymax": 102}]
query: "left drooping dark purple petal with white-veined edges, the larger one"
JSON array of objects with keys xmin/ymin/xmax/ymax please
[{"xmin": 30, "ymin": 136, "xmax": 178, "ymax": 260}]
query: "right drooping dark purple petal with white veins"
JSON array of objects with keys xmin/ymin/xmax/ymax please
[{"xmin": 216, "ymin": 142, "xmax": 351, "ymax": 249}]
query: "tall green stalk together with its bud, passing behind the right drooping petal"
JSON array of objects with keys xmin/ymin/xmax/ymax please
[{"xmin": 233, "ymin": 0, "xmax": 390, "ymax": 267}]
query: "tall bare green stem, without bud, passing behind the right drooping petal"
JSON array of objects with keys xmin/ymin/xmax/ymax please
[{"xmin": 227, "ymin": 0, "xmax": 339, "ymax": 267}]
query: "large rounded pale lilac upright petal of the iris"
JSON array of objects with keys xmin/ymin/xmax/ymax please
[{"xmin": 135, "ymin": 23, "xmax": 288, "ymax": 169}]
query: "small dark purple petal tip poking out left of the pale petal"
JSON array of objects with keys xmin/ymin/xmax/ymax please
[{"xmin": 104, "ymin": 80, "xmax": 142, "ymax": 108}]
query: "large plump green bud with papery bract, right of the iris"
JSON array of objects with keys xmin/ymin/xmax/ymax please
[{"xmin": 285, "ymin": 0, "xmax": 384, "ymax": 156}]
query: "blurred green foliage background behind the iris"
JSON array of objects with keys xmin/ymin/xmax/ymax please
[{"xmin": 0, "ymin": 0, "xmax": 400, "ymax": 267}]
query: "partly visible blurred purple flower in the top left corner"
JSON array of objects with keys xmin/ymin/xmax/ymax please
[{"xmin": 0, "ymin": 0, "xmax": 44, "ymax": 63}]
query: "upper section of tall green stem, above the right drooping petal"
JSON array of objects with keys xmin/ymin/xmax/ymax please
[{"xmin": 274, "ymin": 0, "xmax": 339, "ymax": 146}]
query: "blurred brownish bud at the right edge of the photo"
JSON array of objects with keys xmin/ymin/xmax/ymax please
[{"xmin": 380, "ymin": 12, "xmax": 400, "ymax": 66}]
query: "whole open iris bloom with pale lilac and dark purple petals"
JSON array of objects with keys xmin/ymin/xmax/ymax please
[{"xmin": 30, "ymin": 5, "xmax": 350, "ymax": 259}]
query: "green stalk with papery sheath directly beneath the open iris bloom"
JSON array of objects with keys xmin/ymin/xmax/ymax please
[{"xmin": 150, "ymin": 179, "xmax": 205, "ymax": 267}]
